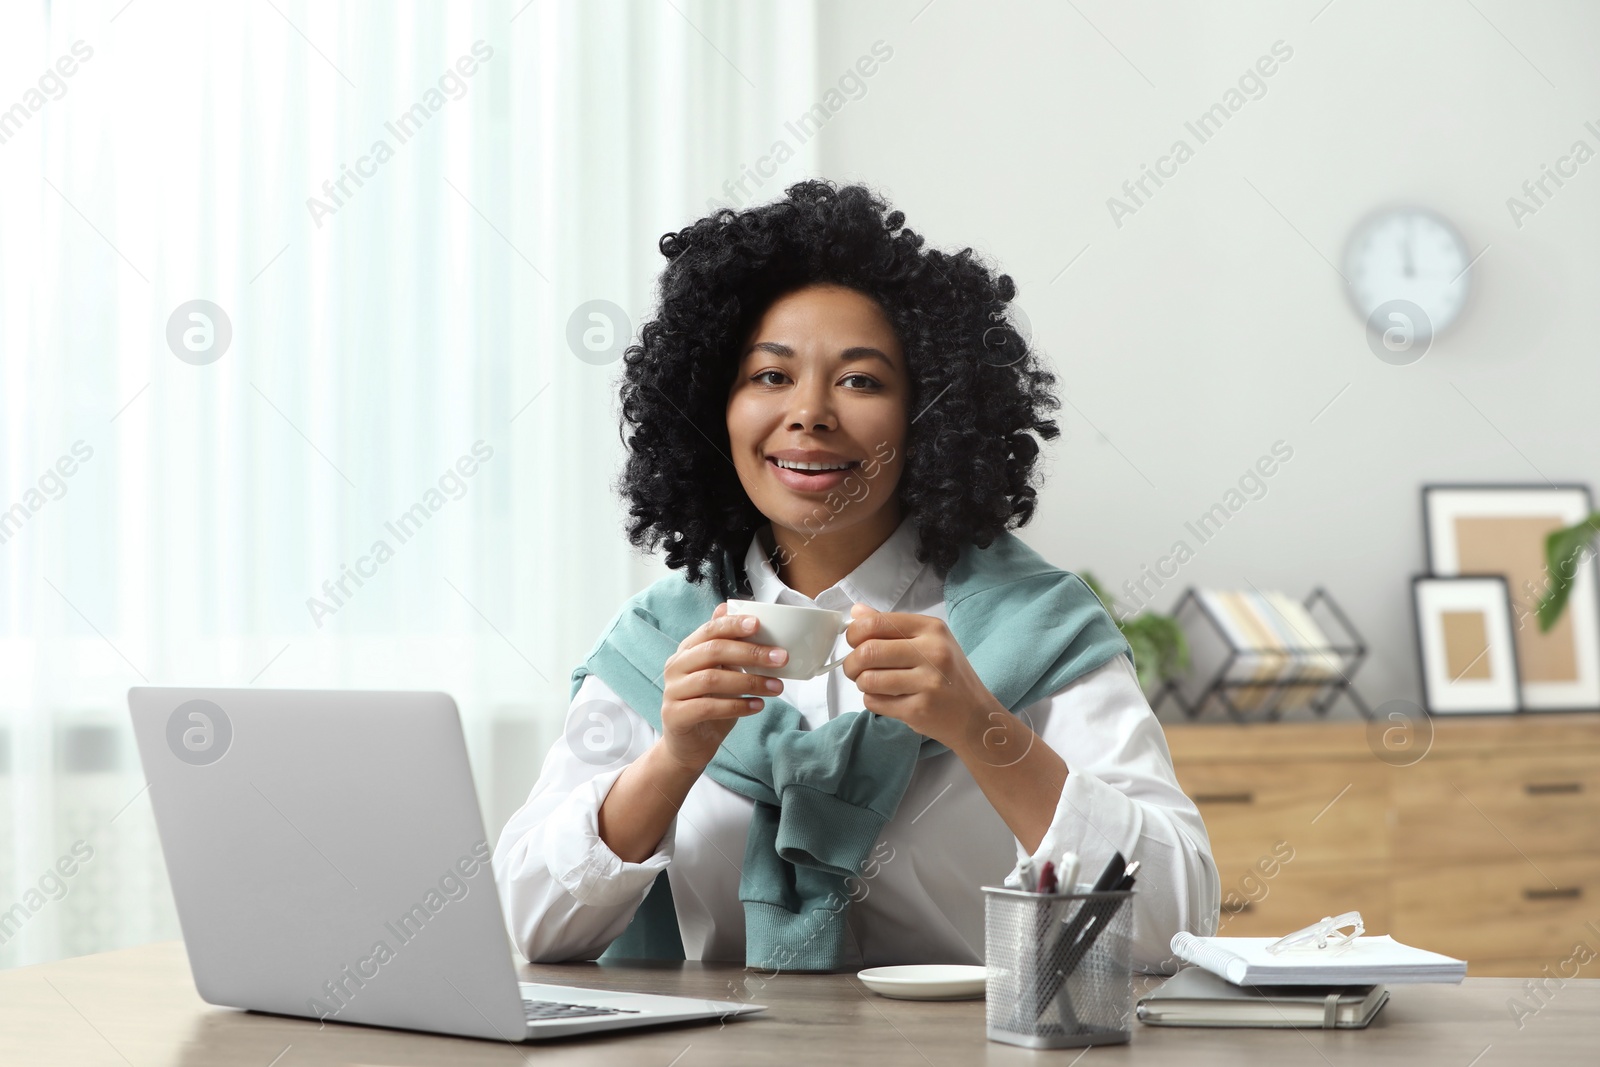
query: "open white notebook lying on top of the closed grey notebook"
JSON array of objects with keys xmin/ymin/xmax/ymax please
[{"xmin": 1173, "ymin": 931, "xmax": 1467, "ymax": 985}]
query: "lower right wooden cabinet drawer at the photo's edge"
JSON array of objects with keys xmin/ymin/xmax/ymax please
[{"xmin": 1394, "ymin": 854, "xmax": 1600, "ymax": 963}]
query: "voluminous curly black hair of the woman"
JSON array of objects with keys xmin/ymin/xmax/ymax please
[{"xmin": 616, "ymin": 181, "xmax": 1061, "ymax": 598}]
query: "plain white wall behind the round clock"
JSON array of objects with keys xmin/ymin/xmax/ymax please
[{"xmin": 819, "ymin": 0, "xmax": 1600, "ymax": 716}]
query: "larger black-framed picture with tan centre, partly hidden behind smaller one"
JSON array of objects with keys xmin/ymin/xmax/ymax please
[{"xmin": 1422, "ymin": 485, "xmax": 1600, "ymax": 712}]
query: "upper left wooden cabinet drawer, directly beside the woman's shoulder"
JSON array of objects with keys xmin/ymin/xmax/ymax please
[{"xmin": 1176, "ymin": 760, "xmax": 1390, "ymax": 870}]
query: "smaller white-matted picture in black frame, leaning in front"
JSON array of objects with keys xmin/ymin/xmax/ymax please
[{"xmin": 1411, "ymin": 574, "xmax": 1522, "ymax": 715}]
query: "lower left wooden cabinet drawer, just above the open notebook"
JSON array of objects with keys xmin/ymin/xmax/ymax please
[{"xmin": 1218, "ymin": 853, "xmax": 1390, "ymax": 937}]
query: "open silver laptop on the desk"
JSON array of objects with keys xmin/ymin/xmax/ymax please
[{"xmin": 128, "ymin": 686, "xmax": 763, "ymax": 1041}]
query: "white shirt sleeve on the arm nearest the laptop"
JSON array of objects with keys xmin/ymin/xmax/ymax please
[{"xmin": 493, "ymin": 675, "xmax": 677, "ymax": 963}]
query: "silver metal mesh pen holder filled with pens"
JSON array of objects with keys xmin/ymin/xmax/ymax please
[{"xmin": 982, "ymin": 885, "xmax": 1134, "ymax": 1048}]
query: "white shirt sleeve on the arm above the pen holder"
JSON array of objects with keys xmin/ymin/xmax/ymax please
[{"xmin": 1008, "ymin": 656, "xmax": 1221, "ymax": 974}]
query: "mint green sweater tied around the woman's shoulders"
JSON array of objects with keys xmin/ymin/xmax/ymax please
[{"xmin": 571, "ymin": 531, "xmax": 1133, "ymax": 971}]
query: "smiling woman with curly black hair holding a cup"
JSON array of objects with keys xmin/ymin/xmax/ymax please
[{"xmin": 494, "ymin": 181, "xmax": 1219, "ymax": 971}]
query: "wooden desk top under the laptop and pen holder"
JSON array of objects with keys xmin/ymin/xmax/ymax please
[{"xmin": 0, "ymin": 941, "xmax": 1600, "ymax": 1067}]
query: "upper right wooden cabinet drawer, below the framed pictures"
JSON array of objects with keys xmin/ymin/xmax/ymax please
[{"xmin": 1394, "ymin": 752, "xmax": 1600, "ymax": 861}]
